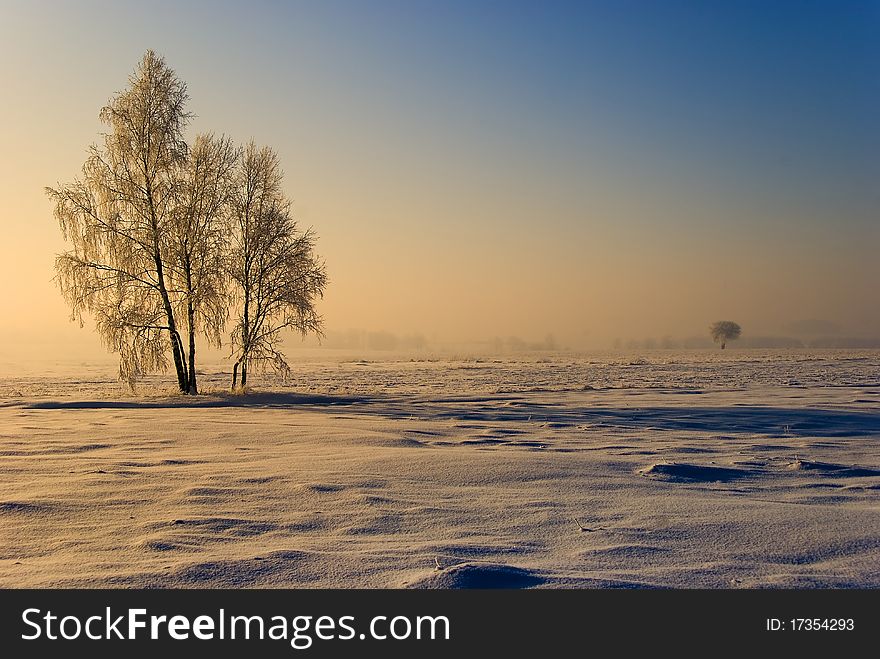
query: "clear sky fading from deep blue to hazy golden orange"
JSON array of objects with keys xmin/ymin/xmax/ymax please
[{"xmin": 0, "ymin": 0, "xmax": 880, "ymax": 357}]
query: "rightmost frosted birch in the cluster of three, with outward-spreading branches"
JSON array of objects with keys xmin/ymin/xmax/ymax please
[{"xmin": 229, "ymin": 142, "xmax": 327, "ymax": 389}]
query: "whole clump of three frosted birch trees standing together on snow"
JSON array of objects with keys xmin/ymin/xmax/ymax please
[{"xmin": 47, "ymin": 51, "xmax": 327, "ymax": 394}]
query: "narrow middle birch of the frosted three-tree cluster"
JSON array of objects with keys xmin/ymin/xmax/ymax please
[{"xmin": 165, "ymin": 135, "xmax": 238, "ymax": 394}]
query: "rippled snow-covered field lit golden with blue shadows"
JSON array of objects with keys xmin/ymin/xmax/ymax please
[{"xmin": 0, "ymin": 349, "xmax": 880, "ymax": 588}]
